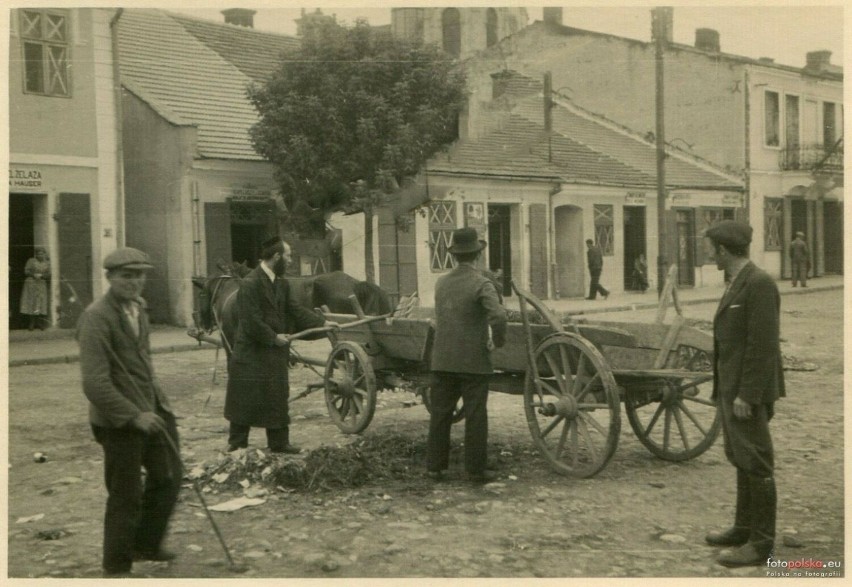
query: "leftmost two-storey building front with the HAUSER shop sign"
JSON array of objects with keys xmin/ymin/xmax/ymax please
[{"xmin": 8, "ymin": 7, "xmax": 125, "ymax": 329}]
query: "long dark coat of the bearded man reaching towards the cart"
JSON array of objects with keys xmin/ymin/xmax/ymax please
[{"xmin": 225, "ymin": 266, "xmax": 325, "ymax": 428}]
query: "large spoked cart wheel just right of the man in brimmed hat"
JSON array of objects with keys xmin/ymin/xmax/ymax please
[{"xmin": 524, "ymin": 332, "xmax": 621, "ymax": 477}]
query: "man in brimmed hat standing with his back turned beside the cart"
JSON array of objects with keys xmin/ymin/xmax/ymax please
[{"xmin": 427, "ymin": 228, "xmax": 506, "ymax": 483}]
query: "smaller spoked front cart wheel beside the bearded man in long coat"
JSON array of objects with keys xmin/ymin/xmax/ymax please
[{"xmin": 325, "ymin": 341, "xmax": 376, "ymax": 434}]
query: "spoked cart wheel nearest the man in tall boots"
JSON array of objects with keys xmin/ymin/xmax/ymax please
[{"xmin": 624, "ymin": 346, "xmax": 722, "ymax": 461}]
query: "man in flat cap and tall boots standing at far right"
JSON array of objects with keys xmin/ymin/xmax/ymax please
[{"xmin": 705, "ymin": 220, "xmax": 785, "ymax": 567}]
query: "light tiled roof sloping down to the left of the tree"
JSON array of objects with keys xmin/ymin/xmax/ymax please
[{"xmin": 118, "ymin": 9, "xmax": 296, "ymax": 161}]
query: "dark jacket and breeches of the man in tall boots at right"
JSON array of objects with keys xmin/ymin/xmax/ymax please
[{"xmin": 713, "ymin": 262, "xmax": 785, "ymax": 477}]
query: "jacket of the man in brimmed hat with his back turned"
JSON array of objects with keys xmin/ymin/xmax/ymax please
[{"xmin": 431, "ymin": 263, "xmax": 506, "ymax": 374}]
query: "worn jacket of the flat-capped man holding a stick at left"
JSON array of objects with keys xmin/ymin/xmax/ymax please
[{"xmin": 77, "ymin": 291, "xmax": 171, "ymax": 428}]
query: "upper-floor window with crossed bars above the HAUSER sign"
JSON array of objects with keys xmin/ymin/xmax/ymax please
[{"xmin": 20, "ymin": 10, "xmax": 71, "ymax": 96}]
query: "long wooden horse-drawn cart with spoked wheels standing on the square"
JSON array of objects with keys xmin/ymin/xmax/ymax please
[{"xmin": 306, "ymin": 284, "xmax": 720, "ymax": 477}]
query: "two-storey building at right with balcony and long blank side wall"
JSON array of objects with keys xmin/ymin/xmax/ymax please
[{"xmin": 466, "ymin": 9, "xmax": 843, "ymax": 276}]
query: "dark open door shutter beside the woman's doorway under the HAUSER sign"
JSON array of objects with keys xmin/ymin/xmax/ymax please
[{"xmin": 57, "ymin": 194, "xmax": 93, "ymax": 328}]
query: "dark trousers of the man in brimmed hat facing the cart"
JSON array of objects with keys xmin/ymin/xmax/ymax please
[{"xmin": 426, "ymin": 371, "xmax": 488, "ymax": 475}]
